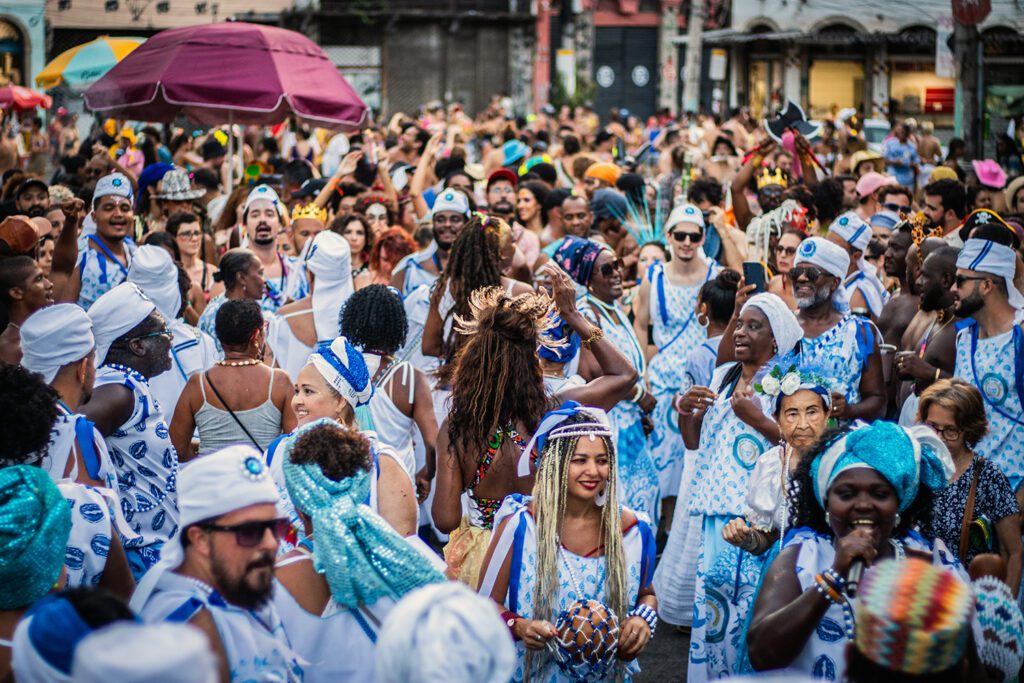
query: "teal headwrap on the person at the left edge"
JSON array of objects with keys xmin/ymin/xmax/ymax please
[{"xmin": 0, "ymin": 465, "xmax": 71, "ymax": 609}]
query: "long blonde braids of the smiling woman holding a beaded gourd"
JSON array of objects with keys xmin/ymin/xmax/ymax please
[{"xmin": 525, "ymin": 411, "xmax": 628, "ymax": 680}]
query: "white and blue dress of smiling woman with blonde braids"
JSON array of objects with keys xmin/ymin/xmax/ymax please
[{"xmin": 480, "ymin": 494, "xmax": 655, "ymax": 683}]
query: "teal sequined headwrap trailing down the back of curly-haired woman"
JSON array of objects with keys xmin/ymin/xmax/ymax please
[{"xmin": 283, "ymin": 420, "xmax": 445, "ymax": 609}]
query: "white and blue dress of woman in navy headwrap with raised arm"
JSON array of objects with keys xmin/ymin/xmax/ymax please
[{"xmin": 577, "ymin": 294, "xmax": 658, "ymax": 524}]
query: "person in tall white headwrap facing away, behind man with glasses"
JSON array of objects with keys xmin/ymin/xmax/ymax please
[{"xmin": 128, "ymin": 245, "xmax": 217, "ymax": 415}]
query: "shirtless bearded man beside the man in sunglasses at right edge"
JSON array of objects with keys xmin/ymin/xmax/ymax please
[{"xmin": 890, "ymin": 248, "xmax": 959, "ymax": 426}]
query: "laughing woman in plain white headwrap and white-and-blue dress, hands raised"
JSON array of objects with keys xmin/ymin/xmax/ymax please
[{"xmin": 678, "ymin": 294, "xmax": 801, "ymax": 681}]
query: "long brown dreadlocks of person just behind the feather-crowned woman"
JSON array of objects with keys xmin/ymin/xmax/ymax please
[{"xmin": 430, "ymin": 215, "xmax": 512, "ymax": 381}]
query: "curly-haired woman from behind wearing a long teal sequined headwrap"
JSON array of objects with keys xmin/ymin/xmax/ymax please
[{"xmin": 273, "ymin": 419, "xmax": 444, "ymax": 683}]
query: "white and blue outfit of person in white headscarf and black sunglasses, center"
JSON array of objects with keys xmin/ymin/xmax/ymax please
[{"xmin": 647, "ymin": 262, "xmax": 721, "ymax": 498}]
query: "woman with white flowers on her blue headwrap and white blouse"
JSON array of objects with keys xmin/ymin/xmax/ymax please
[{"xmin": 687, "ymin": 365, "xmax": 831, "ymax": 680}]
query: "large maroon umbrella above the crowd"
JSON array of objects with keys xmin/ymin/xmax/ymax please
[{"xmin": 85, "ymin": 22, "xmax": 368, "ymax": 130}]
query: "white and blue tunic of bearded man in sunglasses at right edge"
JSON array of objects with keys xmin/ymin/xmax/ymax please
[{"xmin": 953, "ymin": 324, "xmax": 1024, "ymax": 490}]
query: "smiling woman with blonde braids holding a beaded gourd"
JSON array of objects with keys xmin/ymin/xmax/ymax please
[{"xmin": 479, "ymin": 401, "xmax": 657, "ymax": 683}]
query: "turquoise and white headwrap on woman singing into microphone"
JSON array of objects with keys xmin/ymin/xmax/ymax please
[{"xmin": 811, "ymin": 420, "xmax": 954, "ymax": 512}]
